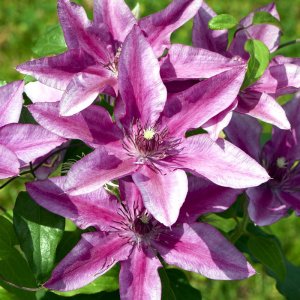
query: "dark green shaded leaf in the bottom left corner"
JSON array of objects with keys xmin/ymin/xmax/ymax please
[{"xmin": 0, "ymin": 216, "xmax": 37, "ymax": 300}]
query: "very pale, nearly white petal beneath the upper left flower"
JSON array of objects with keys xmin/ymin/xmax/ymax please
[{"xmin": 24, "ymin": 81, "xmax": 63, "ymax": 103}]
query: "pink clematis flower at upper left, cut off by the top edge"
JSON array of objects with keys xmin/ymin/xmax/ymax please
[{"xmin": 17, "ymin": 0, "xmax": 202, "ymax": 116}]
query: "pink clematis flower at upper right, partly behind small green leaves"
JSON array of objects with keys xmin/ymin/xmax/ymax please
[{"xmin": 162, "ymin": 2, "xmax": 300, "ymax": 139}]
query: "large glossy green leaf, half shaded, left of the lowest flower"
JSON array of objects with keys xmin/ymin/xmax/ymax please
[{"xmin": 14, "ymin": 192, "xmax": 65, "ymax": 282}]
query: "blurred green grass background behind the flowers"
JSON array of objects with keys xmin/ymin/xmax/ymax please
[{"xmin": 0, "ymin": 0, "xmax": 300, "ymax": 300}]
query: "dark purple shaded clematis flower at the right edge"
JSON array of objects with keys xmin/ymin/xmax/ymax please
[{"xmin": 225, "ymin": 94, "xmax": 300, "ymax": 226}]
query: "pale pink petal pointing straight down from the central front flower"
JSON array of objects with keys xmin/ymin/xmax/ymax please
[{"xmin": 132, "ymin": 166, "xmax": 188, "ymax": 226}]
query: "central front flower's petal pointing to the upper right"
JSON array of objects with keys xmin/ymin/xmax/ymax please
[{"xmin": 162, "ymin": 67, "xmax": 245, "ymax": 136}]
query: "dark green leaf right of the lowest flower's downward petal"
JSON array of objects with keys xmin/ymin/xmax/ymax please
[{"xmin": 159, "ymin": 268, "xmax": 202, "ymax": 300}]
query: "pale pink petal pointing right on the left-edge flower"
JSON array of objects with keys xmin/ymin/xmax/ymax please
[{"xmin": 0, "ymin": 124, "xmax": 66, "ymax": 163}]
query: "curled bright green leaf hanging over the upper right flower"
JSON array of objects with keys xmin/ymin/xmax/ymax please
[{"xmin": 242, "ymin": 40, "xmax": 270, "ymax": 89}]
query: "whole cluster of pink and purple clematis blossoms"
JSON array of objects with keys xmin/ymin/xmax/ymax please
[{"xmin": 0, "ymin": 0, "xmax": 300, "ymax": 300}]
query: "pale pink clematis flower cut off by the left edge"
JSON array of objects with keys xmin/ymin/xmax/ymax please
[{"xmin": 0, "ymin": 81, "xmax": 65, "ymax": 179}]
